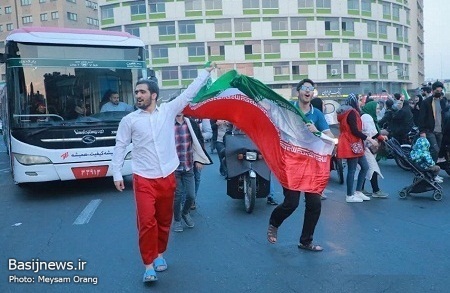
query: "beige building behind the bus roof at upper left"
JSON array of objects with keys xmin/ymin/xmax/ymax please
[{"xmin": 0, "ymin": 0, "xmax": 99, "ymax": 80}]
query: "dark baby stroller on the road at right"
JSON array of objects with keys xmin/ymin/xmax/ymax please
[{"xmin": 386, "ymin": 138, "xmax": 443, "ymax": 200}]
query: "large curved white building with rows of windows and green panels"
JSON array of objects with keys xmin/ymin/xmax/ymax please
[{"xmin": 98, "ymin": 0, "xmax": 424, "ymax": 93}]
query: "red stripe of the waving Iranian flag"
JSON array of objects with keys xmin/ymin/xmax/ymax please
[{"xmin": 183, "ymin": 95, "xmax": 331, "ymax": 193}]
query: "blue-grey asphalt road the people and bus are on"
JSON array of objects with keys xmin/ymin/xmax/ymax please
[{"xmin": 0, "ymin": 140, "xmax": 450, "ymax": 293}]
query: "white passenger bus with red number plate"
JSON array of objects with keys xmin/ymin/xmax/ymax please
[{"xmin": 0, "ymin": 27, "xmax": 147, "ymax": 183}]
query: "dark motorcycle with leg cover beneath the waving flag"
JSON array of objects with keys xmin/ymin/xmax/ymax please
[{"xmin": 224, "ymin": 133, "xmax": 270, "ymax": 213}]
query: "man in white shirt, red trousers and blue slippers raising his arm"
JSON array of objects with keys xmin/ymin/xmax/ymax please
[{"xmin": 112, "ymin": 62, "xmax": 216, "ymax": 282}]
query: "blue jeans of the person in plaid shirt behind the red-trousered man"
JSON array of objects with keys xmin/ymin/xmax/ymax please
[{"xmin": 173, "ymin": 169, "xmax": 195, "ymax": 221}]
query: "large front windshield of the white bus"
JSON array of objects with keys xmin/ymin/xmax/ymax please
[{"xmin": 6, "ymin": 42, "xmax": 146, "ymax": 129}]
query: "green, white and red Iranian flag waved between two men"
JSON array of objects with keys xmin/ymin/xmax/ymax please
[{"xmin": 183, "ymin": 70, "xmax": 334, "ymax": 193}]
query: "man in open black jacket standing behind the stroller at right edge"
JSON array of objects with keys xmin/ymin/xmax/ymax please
[{"xmin": 418, "ymin": 81, "xmax": 448, "ymax": 162}]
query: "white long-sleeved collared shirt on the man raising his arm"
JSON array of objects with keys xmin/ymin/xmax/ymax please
[{"xmin": 112, "ymin": 70, "xmax": 209, "ymax": 181}]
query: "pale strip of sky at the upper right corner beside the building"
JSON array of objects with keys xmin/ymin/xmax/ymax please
[{"xmin": 423, "ymin": 0, "xmax": 450, "ymax": 80}]
